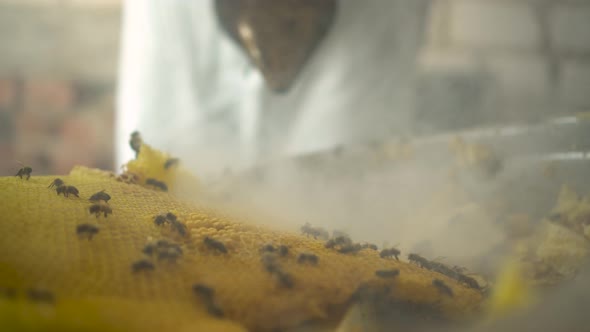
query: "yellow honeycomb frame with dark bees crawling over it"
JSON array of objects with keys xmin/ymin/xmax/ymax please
[{"xmin": 0, "ymin": 147, "xmax": 482, "ymax": 331}]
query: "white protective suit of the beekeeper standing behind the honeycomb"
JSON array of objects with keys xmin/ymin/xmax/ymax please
[{"xmin": 117, "ymin": 0, "xmax": 428, "ymax": 175}]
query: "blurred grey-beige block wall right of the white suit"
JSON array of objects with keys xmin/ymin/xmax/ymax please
[{"xmin": 418, "ymin": 0, "xmax": 590, "ymax": 134}]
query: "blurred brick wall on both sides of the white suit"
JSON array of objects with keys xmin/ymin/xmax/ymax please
[{"xmin": 0, "ymin": 0, "xmax": 590, "ymax": 175}]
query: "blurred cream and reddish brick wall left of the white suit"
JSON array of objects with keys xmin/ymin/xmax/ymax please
[{"xmin": 0, "ymin": 0, "xmax": 120, "ymax": 175}]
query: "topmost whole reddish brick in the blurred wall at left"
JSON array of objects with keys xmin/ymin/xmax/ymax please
[{"xmin": 24, "ymin": 80, "xmax": 75, "ymax": 112}]
